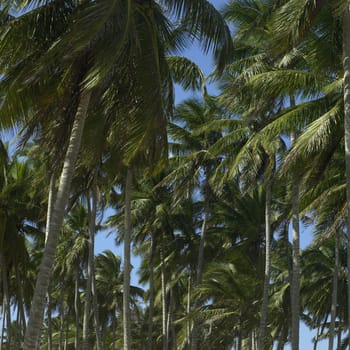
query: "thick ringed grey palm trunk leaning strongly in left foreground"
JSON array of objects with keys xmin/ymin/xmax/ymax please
[{"xmin": 24, "ymin": 90, "xmax": 91, "ymax": 350}]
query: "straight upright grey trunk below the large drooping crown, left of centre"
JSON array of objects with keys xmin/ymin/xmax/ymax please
[{"xmin": 123, "ymin": 166, "xmax": 133, "ymax": 350}]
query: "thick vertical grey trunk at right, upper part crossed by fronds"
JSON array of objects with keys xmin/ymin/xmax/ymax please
[{"xmin": 290, "ymin": 129, "xmax": 300, "ymax": 350}]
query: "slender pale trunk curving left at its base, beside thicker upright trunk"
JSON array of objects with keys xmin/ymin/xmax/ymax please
[{"xmin": 258, "ymin": 180, "xmax": 272, "ymax": 350}]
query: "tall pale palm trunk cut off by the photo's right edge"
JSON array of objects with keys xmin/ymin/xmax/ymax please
[{"xmin": 343, "ymin": 2, "xmax": 350, "ymax": 336}]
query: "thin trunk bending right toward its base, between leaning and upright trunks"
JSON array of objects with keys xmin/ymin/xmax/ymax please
[{"xmin": 89, "ymin": 178, "xmax": 102, "ymax": 350}]
